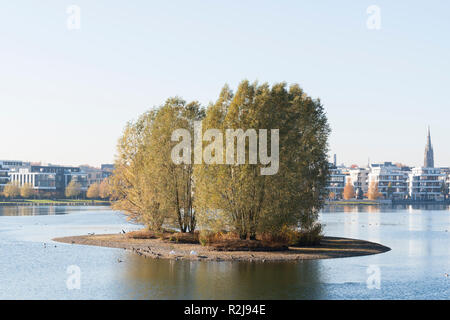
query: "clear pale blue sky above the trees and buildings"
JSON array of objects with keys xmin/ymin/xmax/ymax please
[{"xmin": 0, "ymin": 0, "xmax": 450, "ymax": 166}]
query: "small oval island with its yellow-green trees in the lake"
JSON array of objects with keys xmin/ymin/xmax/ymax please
[{"xmin": 55, "ymin": 80, "xmax": 390, "ymax": 261}]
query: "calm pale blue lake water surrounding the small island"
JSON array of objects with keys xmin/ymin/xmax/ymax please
[{"xmin": 0, "ymin": 206, "xmax": 450, "ymax": 299}]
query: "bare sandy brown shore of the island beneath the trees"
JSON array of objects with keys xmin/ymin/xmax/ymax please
[{"xmin": 53, "ymin": 234, "xmax": 390, "ymax": 262}]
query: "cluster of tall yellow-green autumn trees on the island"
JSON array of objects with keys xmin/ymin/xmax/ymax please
[{"xmin": 110, "ymin": 81, "xmax": 330, "ymax": 239}]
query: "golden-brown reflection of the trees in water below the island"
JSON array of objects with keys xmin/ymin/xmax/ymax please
[{"xmin": 121, "ymin": 255, "xmax": 325, "ymax": 299}]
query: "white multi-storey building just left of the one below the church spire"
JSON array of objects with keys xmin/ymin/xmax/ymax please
[{"xmin": 368, "ymin": 162, "xmax": 408, "ymax": 200}]
